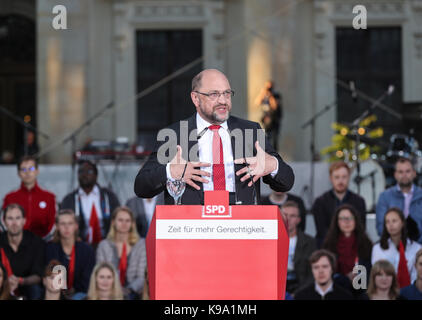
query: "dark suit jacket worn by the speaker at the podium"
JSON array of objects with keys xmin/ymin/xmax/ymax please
[{"xmin": 134, "ymin": 114, "xmax": 294, "ymax": 205}]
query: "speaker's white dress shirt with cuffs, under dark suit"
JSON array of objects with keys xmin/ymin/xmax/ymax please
[{"xmin": 166, "ymin": 113, "xmax": 278, "ymax": 192}]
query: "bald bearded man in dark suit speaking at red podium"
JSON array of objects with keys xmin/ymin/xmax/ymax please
[{"xmin": 135, "ymin": 69, "xmax": 294, "ymax": 204}]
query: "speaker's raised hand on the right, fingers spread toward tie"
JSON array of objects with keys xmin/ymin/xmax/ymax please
[{"xmin": 234, "ymin": 141, "xmax": 278, "ymax": 187}]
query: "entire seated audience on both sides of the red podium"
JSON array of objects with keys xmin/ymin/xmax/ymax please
[{"xmin": 0, "ymin": 156, "xmax": 422, "ymax": 300}]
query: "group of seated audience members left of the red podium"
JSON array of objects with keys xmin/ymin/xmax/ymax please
[{"xmin": 0, "ymin": 156, "xmax": 158, "ymax": 300}]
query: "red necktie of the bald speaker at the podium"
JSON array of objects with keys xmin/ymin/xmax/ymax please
[{"xmin": 209, "ymin": 125, "xmax": 226, "ymax": 190}]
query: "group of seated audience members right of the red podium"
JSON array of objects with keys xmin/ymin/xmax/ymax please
[{"xmin": 263, "ymin": 158, "xmax": 422, "ymax": 300}]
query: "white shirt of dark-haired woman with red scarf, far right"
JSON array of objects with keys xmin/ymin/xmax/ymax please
[{"xmin": 371, "ymin": 238, "xmax": 422, "ymax": 283}]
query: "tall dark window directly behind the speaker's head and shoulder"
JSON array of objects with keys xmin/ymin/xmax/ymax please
[{"xmin": 136, "ymin": 30, "xmax": 202, "ymax": 150}]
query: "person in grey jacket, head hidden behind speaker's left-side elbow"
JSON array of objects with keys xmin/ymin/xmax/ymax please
[{"xmin": 126, "ymin": 193, "xmax": 164, "ymax": 238}]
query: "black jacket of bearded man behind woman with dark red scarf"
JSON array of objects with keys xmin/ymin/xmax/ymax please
[{"xmin": 312, "ymin": 190, "xmax": 366, "ymax": 248}]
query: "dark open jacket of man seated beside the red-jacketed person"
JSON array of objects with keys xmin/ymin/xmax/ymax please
[{"xmin": 60, "ymin": 186, "xmax": 120, "ymax": 241}]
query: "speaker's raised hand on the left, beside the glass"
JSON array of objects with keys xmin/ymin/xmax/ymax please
[{"xmin": 170, "ymin": 145, "xmax": 211, "ymax": 190}]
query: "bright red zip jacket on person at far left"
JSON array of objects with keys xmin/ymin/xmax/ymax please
[{"xmin": 2, "ymin": 183, "xmax": 56, "ymax": 240}]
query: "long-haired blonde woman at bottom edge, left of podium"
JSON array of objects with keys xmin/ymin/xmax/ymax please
[{"xmin": 86, "ymin": 262, "xmax": 123, "ymax": 300}]
